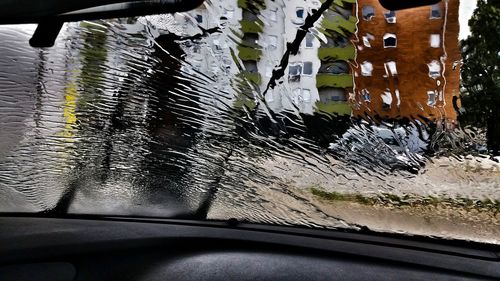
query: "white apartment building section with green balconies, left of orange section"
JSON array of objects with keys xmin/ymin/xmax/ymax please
[{"xmin": 176, "ymin": 0, "xmax": 357, "ymax": 115}]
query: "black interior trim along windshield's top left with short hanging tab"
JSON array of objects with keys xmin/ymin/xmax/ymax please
[{"xmin": 0, "ymin": 0, "xmax": 204, "ymax": 47}]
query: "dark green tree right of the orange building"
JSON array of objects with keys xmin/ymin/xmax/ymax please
[{"xmin": 460, "ymin": 0, "xmax": 500, "ymax": 155}]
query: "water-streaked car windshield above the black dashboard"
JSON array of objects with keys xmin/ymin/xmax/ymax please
[{"xmin": 0, "ymin": 0, "xmax": 500, "ymax": 244}]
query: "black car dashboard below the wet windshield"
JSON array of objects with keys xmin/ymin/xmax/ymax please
[{"xmin": 0, "ymin": 217, "xmax": 500, "ymax": 281}]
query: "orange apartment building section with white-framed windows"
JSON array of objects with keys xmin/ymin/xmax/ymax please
[{"xmin": 351, "ymin": 0, "xmax": 461, "ymax": 126}]
